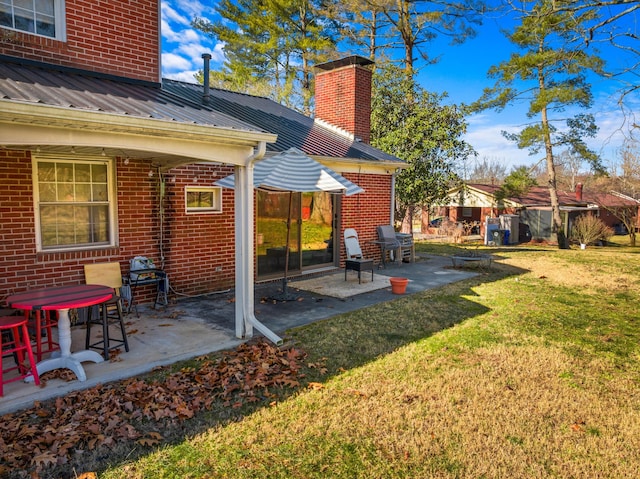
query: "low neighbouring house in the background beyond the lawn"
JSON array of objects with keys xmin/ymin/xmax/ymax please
[{"xmin": 443, "ymin": 183, "xmax": 640, "ymax": 242}]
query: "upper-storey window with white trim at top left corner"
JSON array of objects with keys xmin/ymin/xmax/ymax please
[{"xmin": 0, "ymin": 0, "xmax": 65, "ymax": 40}]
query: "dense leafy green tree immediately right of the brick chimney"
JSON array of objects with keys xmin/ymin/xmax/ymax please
[{"xmin": 371, "ymin": 65, "xmax": 475, "ymax": 233}]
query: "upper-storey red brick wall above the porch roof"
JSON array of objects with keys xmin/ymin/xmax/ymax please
[{"xmin": 0, "ymin": 0, "xmax": 160, "ymax": 82}]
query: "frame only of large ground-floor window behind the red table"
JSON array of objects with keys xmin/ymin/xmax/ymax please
[{"xmin": 32, "ymin": 155, "xmax": 118, "ymax": 253}]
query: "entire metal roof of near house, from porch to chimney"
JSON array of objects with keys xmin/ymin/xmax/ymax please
[{"xmin": 0, "ymin": 57, "xmax": 405, "ymax": 165}]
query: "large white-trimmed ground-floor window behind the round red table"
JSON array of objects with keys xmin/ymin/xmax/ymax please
[{"xmin": 33, "ymin": 157, "xmax": 117, "ymax": 251}]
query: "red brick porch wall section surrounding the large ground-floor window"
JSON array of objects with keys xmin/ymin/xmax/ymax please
[{"xmin": 0, "ymin": 149, "xmax": 159, "ymax": 302}]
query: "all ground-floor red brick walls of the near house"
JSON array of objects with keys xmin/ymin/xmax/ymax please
[{"xmin": 0, "ymin": 154, "xmax": 391, "ymax": 303}]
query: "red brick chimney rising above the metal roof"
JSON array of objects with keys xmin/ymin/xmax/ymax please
[{"xmin": 315, "ymin": 55, "xmax": 373, "ymax": 143}]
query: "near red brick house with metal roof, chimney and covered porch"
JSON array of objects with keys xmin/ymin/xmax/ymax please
[{"xmin": 0, "ymin": 0, "xmax": 406, "ymax": 342}]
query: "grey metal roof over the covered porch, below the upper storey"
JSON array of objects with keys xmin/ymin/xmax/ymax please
[{"xmin": 0, "ymin": 61, "xmax": 265, "ymax": 132}]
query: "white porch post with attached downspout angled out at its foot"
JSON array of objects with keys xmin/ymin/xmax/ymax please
[{"xmin": 234, "ymin": 141, "xmax": 282, "ymax": 345}]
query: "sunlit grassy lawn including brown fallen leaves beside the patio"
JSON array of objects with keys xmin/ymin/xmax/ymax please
[{"xmin": 0, "ymin": 238, "xmax": 640, "ymax": 479}]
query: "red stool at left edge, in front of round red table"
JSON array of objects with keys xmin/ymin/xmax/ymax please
[{"xmin": 0, "ymin": 316, "xmax": 40, "ymax": 397}]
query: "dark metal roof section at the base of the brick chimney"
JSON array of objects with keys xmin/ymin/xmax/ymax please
[{"xmin": 162, "ymin": 79, "xmax": 404, "ymax": 164}]
